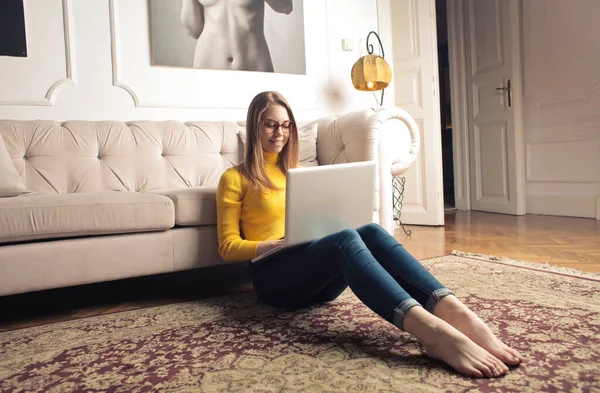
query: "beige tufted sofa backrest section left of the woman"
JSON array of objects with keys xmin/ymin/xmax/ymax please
[{"xmin": 0, "ymin": 120, "xmax": 243, "ymax": 194}]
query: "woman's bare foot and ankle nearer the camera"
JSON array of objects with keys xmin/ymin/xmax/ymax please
[{"xmin": 404, "ymin": 307, "xmax": 508, "ymax": 378}]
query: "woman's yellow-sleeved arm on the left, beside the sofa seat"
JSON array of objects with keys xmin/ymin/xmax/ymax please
[{"xmin": 217, "ymin": 168, "xmax": 261, "ymax": 262}]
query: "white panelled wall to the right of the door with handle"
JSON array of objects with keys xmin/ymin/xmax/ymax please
[{"xmin": 522, "ymin": 0, "xmax": 600, "ymax": 218}]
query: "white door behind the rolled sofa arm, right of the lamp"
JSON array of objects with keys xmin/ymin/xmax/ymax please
[{"xmin": 390, "ymin": 0, "xmax": 444, "ymax": 225}]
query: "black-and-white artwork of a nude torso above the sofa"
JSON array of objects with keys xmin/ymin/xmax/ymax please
[{"xmin": 148, "ymin": 0, "xmax": 306, "ymax": 75}]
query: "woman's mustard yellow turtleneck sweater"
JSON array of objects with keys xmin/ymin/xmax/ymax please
[{"xmin": 217, "ymin": 150, "xmax": 285, "ymax": 261}]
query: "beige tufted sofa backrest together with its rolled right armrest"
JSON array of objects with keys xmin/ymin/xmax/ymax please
[{"xmin": 0, "ymin": 107, "xmax": 420, "ymax": 233}]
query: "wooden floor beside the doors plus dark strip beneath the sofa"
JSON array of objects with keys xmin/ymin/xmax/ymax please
[{"xmin": 0, "ymin": 212, "xmax": 600, "ymax": 332}]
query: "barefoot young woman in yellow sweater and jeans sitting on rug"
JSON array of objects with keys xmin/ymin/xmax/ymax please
[{"xmin": 217, "ymin": 92, "xmax": 521, "ymax": 377}]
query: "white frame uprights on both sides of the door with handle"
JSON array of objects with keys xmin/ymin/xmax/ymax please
[{"xmin": 446, "ymin": 0, "xmax": 526, "ymax": 214}]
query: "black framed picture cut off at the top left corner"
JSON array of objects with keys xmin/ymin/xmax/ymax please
[{"xmin": 0, "ymin": 0, "xmax": 27, "ymax": 57}]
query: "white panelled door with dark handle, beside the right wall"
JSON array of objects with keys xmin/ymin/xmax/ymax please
[{"xmin": 463, "ymin": 0, "xmax": 525, "ymax": 214}]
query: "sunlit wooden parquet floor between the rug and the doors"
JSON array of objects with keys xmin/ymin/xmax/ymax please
[{"xmin": 396, "ymin": 211, "xmax": 600, "ymax": 272}]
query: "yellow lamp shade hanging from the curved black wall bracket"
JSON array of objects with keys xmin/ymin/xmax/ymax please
[{"xmin": 351, "ymin": 55, "xmax": 392, "ymax": 91}]
